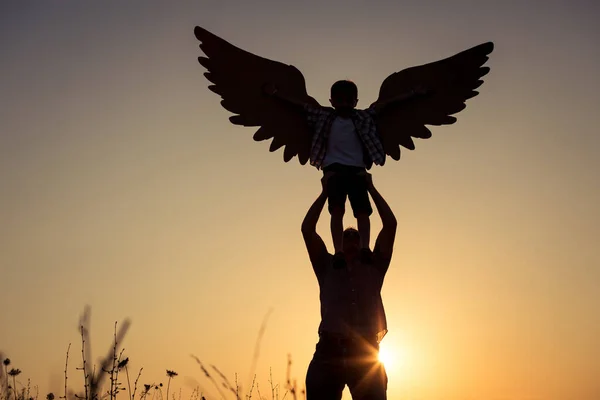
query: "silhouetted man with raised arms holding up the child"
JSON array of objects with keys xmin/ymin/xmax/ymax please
[{"xmin": 302, "ymin": 173, "xmax": 397, "ymax": 400}]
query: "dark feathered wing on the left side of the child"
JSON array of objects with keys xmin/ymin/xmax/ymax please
[{"xmin": 194, "ymin": 26, "xmax": 319, "ymax": 165}]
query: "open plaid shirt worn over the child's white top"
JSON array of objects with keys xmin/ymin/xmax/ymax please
[{"xmin": 304, "ymin": 104, "xmax": 385, "ymax": 169}]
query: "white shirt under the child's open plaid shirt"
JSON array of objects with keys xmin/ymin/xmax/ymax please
[{"xmin": 323, "ymin": 117, "xmax": 365, "ymax": 168}]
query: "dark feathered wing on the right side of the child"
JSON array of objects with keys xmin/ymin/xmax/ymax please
[{"xmin": 373, "ymin": 42, "xmax": 494, "ymax": 160}]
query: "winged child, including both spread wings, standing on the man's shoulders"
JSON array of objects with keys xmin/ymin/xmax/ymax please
[{"xmin": 194, "ymin": 26, "xmax": 494, "ymax": 266}]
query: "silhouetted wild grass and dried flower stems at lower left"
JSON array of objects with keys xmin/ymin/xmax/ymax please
[{"xmin": 0, "ymin": 307, "xmax": 306, "ymax": 400}]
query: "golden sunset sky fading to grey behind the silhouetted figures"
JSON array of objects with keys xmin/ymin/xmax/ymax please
[{"xmin": 0, "ymin": 0, "xmax": 600, "ymax": 400}]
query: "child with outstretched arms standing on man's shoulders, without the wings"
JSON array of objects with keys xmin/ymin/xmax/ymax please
[{"xmin": 263, "ymin": 80, "xmax": 425, "ymax": 268}]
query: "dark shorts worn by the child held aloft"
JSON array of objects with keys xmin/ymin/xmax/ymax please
[{"xmin": 323, "ymin": 163, "xmax": 373, "ymax": 217}]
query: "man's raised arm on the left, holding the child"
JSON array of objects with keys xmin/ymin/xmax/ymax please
[{"xmin": 302, "ymin": 174, "xmax": 330, "ymax": 275}]
